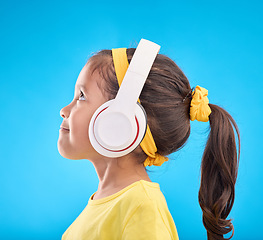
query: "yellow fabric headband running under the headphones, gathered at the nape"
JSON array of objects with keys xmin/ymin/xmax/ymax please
[{"xmin": 112, "ymin": 48, "xmax": 168, "ymax": 167}]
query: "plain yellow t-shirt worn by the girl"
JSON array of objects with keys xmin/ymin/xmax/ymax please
[{"xmin": 62, "ymin": 180, "xmax": 179, "ymax": 240}]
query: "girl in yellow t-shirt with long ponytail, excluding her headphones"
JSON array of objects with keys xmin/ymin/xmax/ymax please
[{"xmin": 58, "ymin": 39, "xmax": 240, "ymax": 240}]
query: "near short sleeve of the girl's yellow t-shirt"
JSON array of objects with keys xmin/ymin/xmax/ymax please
[{"xmin": 122, "ymin": 200, "xmax": 174, "ymax": 240}]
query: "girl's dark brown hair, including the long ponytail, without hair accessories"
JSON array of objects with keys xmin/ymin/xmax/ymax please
[{"xmin": 88, "ymin": 48, "xmax": 240, "ymax": 240}]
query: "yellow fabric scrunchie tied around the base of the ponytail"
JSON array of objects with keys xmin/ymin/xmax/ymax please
[{"xmin": 190, "ymin": 86, "xmax": 212, "ymax": 122}]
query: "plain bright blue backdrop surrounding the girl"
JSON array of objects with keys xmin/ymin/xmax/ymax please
[{"xmin": 0, "ymin": 0, "xmax": 263, "ymax": 240}]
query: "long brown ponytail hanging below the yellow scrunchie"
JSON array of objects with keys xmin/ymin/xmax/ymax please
[{"xmin": 198, "ymin": 104, "xmax": 240, "ymax": 240}]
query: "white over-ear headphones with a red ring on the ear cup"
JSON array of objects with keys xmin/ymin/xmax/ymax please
[{"xmin": 89, "ymin": 39, "xmax": 160, "ymax": 158}]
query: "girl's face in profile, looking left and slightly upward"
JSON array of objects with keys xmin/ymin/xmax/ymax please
[{"xmin": 57, "ymin": 64, "xmax": 107, "ymax": 160}]
